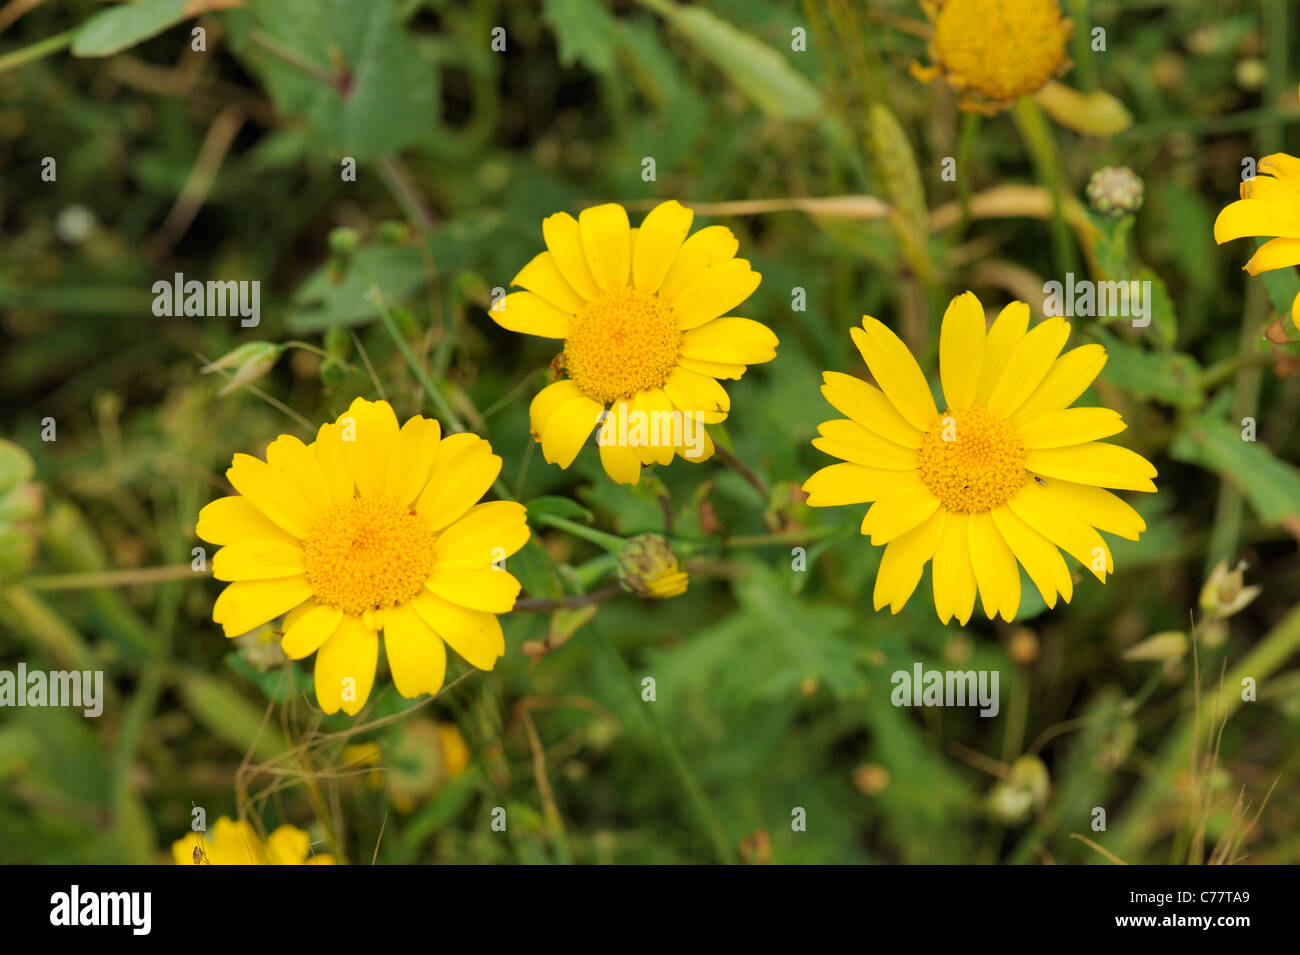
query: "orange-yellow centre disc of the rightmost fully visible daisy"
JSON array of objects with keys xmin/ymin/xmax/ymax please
[{"xmin": 917, "ymin": 408, "xmax": 1028, "ymax": 513}]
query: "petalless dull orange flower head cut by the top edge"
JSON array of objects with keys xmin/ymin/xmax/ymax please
[{"xmin": 933, "ymin": 0, "xmax": 1070, "ymax": 103}]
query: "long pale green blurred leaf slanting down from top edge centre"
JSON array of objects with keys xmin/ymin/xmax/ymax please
[{"xmin": 654, "ymin": 3, "xmax": 822, "ymax": 122}]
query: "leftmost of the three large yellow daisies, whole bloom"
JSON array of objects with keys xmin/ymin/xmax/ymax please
[{"xmin": 196, "ymin": 398, "xmax": 529, "ymax": 715}]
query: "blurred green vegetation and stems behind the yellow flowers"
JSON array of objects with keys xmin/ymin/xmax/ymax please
[{"xmin": 0, "ymin": 0, "xmax": 1300, "ymax": 863}]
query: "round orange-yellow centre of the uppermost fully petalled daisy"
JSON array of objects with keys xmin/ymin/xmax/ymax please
[{"xmin": 564, "ymin": 288, "xmax": 681, "ymax": 404}]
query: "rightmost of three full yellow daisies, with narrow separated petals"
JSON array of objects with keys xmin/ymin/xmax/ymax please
[{"xmin": 803, "ymin": 292, "xmax": 1156, "ymax": 625}]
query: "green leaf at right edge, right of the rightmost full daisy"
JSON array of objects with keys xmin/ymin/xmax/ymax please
[{"xmin": 1169, "ymin": 402, "xmax": 1300, "ymax": 524}]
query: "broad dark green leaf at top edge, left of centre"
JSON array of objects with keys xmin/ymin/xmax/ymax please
[{"xmin": 243, "ymin": 0, "xmax": 437, "ymax": 160}]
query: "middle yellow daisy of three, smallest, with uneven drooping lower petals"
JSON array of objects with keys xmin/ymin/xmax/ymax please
[{"xmin": 489, "ymin": 201, "xmax": 777, "ymax": 485}]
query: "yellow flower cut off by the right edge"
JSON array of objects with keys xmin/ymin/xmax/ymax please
[{"xmin": 1214, "ymin": 152, "xmax": 1300, "ymax": 325}]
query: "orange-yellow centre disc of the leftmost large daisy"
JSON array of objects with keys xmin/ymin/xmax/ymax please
[{"xmin": 303, "ymin": 498, "xmax": 434, "ymax": 616}]
